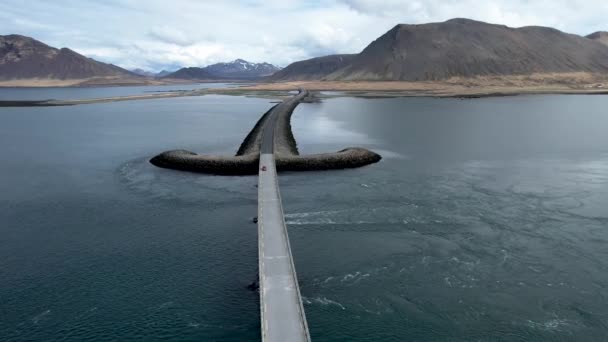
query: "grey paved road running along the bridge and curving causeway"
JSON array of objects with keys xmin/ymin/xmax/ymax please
[{"xmin": 258, "ymin": 90, "xmax": 310, "ymax": 342}]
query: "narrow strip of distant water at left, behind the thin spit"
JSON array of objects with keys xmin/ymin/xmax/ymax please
[{"xmin": 0, "ymin": 83, "xmax": 237, "ymax": 101}]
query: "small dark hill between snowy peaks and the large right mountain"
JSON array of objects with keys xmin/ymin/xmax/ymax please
[{"xmin": 268, "ymin": 55, "xmax": 356, "ymax": 81}]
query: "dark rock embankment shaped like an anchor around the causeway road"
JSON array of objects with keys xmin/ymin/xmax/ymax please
[{"xmin": 150, "ymin": 91, "xmax": 382, "ymax": 175}]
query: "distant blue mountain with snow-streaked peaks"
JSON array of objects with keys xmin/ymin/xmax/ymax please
[{"xmin": 164, "ymin": 59, "xmax": 280, "ymax": 80}]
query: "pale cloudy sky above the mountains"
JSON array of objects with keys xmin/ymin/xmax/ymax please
[{"xmin": 0, "ymin": 0, "xmax": 608, "ymax": 71}]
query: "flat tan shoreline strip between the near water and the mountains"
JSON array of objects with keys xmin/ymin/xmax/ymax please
[{"xmin": 0, "ymin": 81, "xmax": 608, "ymax": 107}]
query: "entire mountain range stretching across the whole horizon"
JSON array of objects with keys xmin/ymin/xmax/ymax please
[{"xmin": 0, "ymin": 19, "xmax": 608, "ymax": 86}]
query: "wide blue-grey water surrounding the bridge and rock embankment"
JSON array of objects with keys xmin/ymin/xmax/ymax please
[{"xmin": 0, "ymin": 92, "xmax": 608, "ymax": 341}]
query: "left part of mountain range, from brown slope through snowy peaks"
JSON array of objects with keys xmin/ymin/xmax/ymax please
[{"xmin": 0, "ymin": 34, "xmax": 279, "ymax": 86}]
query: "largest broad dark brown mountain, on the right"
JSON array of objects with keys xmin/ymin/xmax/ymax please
[{"xmin": 273, "ymin": 19, "xmax": 608, "ymax": 81}]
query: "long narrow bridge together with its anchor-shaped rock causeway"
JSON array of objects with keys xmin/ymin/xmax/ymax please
[{"xmin": 150, "ymin": 89, "xmax": 382, "ymax": 342}]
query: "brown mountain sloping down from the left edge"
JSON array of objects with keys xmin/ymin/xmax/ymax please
[{"xmin": 0, "ymin": 34, "xmax": 136, "ymax": 81}]
